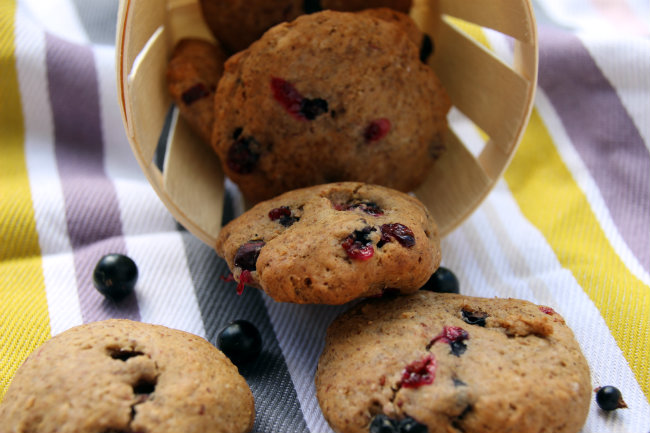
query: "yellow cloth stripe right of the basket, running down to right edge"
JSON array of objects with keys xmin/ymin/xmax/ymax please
[{"xmin": 504, "ymin": 110, "xmax": 650, "ymax": 399}]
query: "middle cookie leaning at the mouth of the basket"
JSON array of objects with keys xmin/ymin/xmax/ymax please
[{"xmin": 216, "ymin": 182, "xmax": 440, "ymax": 304}]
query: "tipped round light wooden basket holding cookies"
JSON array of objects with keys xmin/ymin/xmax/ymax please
[{"xmin": 116, "ymin": 0, "xmax": 537, "ymax": 246}]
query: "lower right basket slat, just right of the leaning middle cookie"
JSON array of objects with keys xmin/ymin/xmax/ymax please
[{"xmin": 415, "ymin": 130, "xmax": 493, "ymax": 236}]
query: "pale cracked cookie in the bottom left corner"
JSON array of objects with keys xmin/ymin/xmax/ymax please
[{"xmin": 0, "ymin": 319, "xmax": 255, "ymax": 433}]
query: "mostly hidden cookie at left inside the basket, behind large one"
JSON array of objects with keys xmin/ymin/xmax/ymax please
[{"xmin": 167, "ymin": 39, "xmax": 226, "ymax": 143}]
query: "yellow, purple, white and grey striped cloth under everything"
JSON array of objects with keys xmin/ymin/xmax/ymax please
[{"xmin": 0, "ymin": 0, "xmax": 650, "ymax": 433}]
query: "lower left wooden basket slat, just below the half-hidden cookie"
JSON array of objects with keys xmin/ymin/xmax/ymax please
[{"xmin": 163, "ymin": 113, "xmax": 224, "ymax": 246}]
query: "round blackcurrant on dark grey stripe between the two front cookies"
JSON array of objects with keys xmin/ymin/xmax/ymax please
[{"xmin": 217, "ymin": 320, "xmax": 262, "ymax": 365}]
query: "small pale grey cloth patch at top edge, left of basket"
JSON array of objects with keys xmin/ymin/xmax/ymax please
[{"xmin": 72, "ymin": 0, "xmax": 119, "ymax": 45}]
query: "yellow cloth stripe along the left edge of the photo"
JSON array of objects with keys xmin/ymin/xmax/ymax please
[{"xmin": 0, "ymin": 0, "xmax": 50, "ymax": 399}]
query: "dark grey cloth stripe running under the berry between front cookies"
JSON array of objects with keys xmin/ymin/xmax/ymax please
[{"xmin": 181, "ymin": 232, "xmax": 309, "ymax": 433}]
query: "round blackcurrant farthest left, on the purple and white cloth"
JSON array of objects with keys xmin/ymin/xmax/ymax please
[{"xmin": 93, "ymin": 254, "xmax": 138, "ymax": 301}]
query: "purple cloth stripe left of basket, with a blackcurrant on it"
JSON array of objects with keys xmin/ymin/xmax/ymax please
[{"xmin": 45, "ymin": 34, "xmax": 140, "ymax": 322}]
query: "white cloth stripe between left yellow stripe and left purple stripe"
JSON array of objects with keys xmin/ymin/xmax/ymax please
[{"xmin": 16, "ymin": 3, "xmax": 83, "ymax": 335}]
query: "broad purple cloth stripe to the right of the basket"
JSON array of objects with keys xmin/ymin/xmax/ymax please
[{"xmin": 539, "ymin": 27, "xmax": 650, "ymax": 272}]
